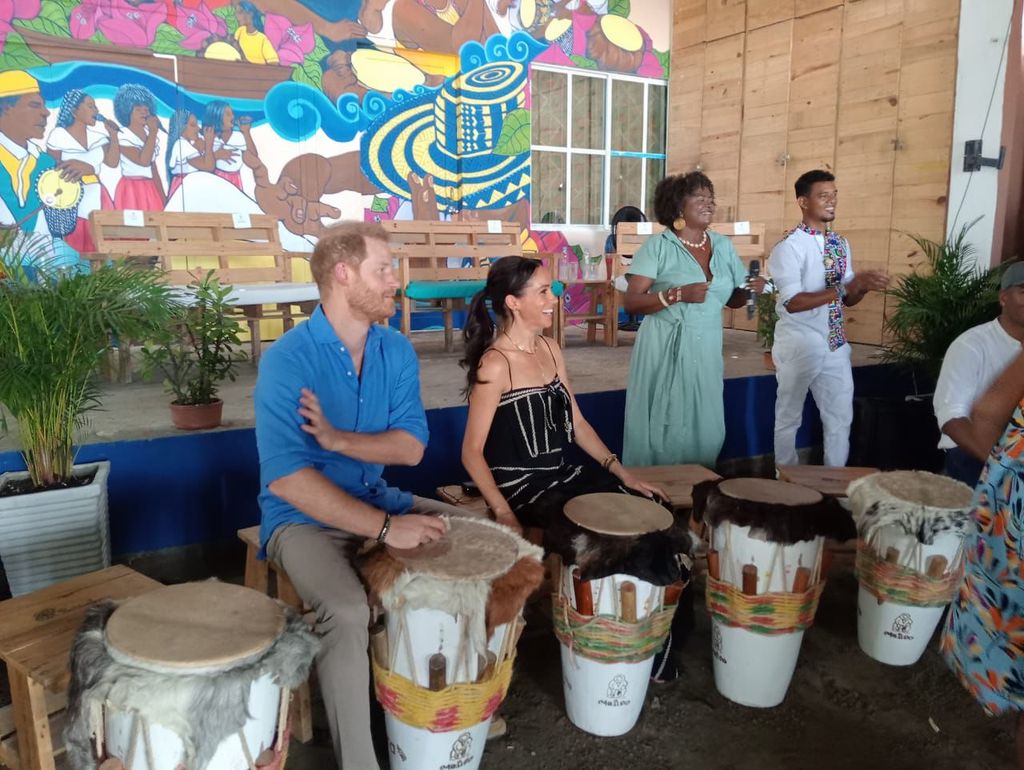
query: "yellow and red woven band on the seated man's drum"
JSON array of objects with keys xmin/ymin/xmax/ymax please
[{"xmin": 373, "ymin": 656, "xmax": 515, "ymax": 732}]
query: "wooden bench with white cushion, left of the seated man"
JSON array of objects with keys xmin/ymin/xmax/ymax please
[{"xmin": 84, "ymin": 210, "xmax": 319, "ymax": 363}]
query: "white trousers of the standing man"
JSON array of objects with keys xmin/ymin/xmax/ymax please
[{"xmin": 772, "ymin": 336, "xmax": 853, "ymax": 466}]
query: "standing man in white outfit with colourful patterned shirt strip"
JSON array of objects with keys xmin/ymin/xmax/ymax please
[{"xmin": 768, "ymin": 170, "xmax": 889, "ymax": 466}]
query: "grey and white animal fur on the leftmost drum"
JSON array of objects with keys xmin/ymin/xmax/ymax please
[{"xmin": 65, "ymin": 601, "xmax": 319, "ymax": 770}]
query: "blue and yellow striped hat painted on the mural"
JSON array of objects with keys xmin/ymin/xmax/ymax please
[{"xmin": 361, "ymin": 61, "xmax": 529, "ymax": 210}]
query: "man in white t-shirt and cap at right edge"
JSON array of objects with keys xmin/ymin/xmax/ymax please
[{"xmin": 932, "ymin": 262, "xmax": 1024, "ymax": 486}]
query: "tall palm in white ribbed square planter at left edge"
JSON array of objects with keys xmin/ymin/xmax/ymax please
[{"xmin": 0, "ymin": 230, "xmax": 170, "ymax": 596}]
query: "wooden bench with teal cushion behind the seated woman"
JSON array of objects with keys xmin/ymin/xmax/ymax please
[{"xmin": 381, "ymin": 219, "xmax": 561, "ymax": 350}]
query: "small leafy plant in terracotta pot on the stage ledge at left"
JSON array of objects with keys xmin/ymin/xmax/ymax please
[{"xmin": 142, "ymin": 270, "xmax": 246, "ymax": 430}]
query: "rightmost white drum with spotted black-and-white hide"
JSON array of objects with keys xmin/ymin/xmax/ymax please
[{"xmin": 850, "ymin": 471, "xmax": 972, "ymax": 666}]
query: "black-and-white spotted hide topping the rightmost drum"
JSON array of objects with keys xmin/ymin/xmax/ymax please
[{"xmin": 849, "ymin": 471, "xmax": 973, "ymax": 546}]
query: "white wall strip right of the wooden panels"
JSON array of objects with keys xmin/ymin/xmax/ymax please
[{"xmin": 946, "ymin": 0, "xmax": 1014, "ymax": 267}]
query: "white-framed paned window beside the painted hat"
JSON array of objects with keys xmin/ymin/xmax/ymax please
[{"xmin": 530, "ymin": 66, "xmax": 668, "ymax": 229}]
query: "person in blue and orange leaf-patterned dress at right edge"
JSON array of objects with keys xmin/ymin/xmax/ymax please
[{"xmin": 942, "ymin": 352, "xmax": 1024, "ymax": 768}]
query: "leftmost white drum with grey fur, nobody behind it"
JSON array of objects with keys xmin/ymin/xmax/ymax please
[{"xmin": 69, "ymin": 582, "xmax": 318, "ymax": 770}]
